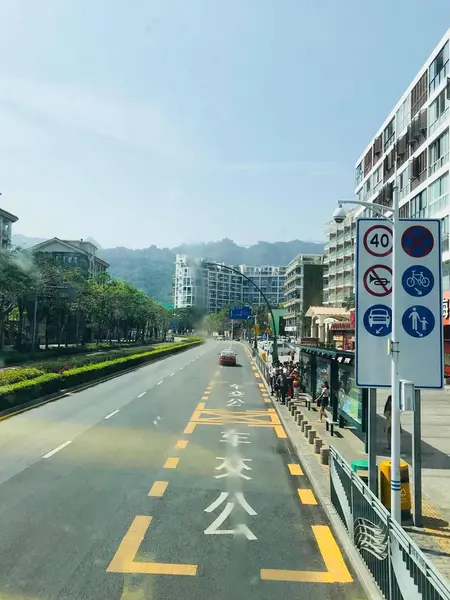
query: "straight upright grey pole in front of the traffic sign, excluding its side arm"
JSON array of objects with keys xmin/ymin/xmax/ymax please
[{"xmin": 390, "ymin": 157, "xmax": 402, "ymax": 524}]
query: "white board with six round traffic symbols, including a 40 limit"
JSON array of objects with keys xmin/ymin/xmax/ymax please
[{"xmin": 355, "ymin": 219, "xmax": 444, "ymax": 389}]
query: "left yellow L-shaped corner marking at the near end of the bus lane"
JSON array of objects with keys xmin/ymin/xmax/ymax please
[{"xmin": 106, "ymin": 516, "xmax": 198, "ymax": 577}]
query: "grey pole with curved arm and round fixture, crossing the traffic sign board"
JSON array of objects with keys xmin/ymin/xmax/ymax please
[{"xmin": 333, "ymin": 190, "xmax": 401, "ymax": 523}]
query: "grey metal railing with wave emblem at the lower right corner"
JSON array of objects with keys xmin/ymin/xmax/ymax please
[{"xmin": 329, "ymin": 447, "xmax": 450, "ymax": 600}]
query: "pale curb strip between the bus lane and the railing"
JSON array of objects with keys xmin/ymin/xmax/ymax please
[{"xmin": 254, "ymin": 361, "xmax": 384, "ymax": 600}]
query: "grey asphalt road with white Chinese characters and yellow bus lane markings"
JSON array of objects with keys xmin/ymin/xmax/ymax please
[{"xmin": 0, "ymin": 342, "xmax": 366, "ymax": 600}]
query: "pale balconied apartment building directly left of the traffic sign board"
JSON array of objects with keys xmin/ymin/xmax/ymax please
[{"xmin": 323, "ymin": 209, "xmax": 358, "ymax": 308}]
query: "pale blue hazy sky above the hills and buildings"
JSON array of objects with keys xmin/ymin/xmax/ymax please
[{"xmin": 0, "ymin": 0, "xmax": 450, "ymax": 248}]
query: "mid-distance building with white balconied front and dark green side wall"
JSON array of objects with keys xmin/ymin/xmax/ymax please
[{"xmin": 284, "ymin": 254, "xmax": 324, "ymax": 335}]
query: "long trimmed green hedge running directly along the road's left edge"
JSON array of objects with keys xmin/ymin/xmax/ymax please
[{"xmin": 0, "ymin": 341, "xmax": 201, "ymax": 411}]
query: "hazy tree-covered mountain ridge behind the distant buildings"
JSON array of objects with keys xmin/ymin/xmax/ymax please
[{"xmin": 12, "ymin": 234, "xmax": 324, "ymax": 302}]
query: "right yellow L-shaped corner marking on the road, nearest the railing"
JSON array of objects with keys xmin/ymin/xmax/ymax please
[{"xmin": 260, "ymin": 525, "xmax": 353, "ymax": 583}]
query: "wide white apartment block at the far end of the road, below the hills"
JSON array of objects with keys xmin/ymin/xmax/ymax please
[{"xmin": 173, "ymin": 254, "xmax": 285, "ymax": 313}]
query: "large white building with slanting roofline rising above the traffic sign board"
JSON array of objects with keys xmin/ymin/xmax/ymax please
[{"xmin": 355, "ymin": 30, "xmax": 450, "ymax": 290}]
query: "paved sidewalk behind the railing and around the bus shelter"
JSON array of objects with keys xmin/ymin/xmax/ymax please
[{"xmin": 277, "ymin": 390, "xmax": 450, "ymax": 580}]
